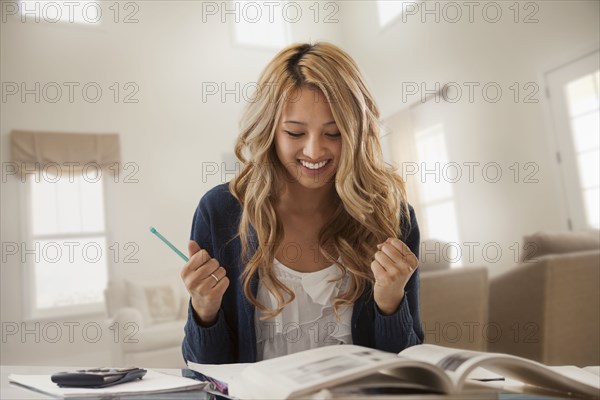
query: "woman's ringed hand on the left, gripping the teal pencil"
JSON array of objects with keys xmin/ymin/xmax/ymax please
[{"xmin": 181, "ymin": 240, "xmax": 229, "ymax": 326}]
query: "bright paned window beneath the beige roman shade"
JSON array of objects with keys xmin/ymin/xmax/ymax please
[{"xmin": 23, "ymin": 170, "xmax": 108, "ymax": 318}]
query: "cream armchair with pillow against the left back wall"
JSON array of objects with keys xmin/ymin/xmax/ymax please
[{"xmin": 104, "ymin": 279, "xmax": 188, "ymax": 368}]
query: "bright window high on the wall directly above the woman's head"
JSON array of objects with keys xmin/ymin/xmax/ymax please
[{"xmin": 232, "ymin": 1, "xmax": 290, "ymax": 49}]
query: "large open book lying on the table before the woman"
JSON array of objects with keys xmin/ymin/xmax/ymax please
[{"xmin": 188, "ymin": 344, "xmax": 600, "ymax": 399}]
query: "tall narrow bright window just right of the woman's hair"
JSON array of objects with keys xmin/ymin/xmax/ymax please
[{"xmin": 415, "ymin": 124, "xmax": 460, "ymax": 265}]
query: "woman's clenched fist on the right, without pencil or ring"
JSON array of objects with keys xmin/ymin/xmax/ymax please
[{"xmin": 371, "ymin": 238, "xmax": 418, "ymax": 315}]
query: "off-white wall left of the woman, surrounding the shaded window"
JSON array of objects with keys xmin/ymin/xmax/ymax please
[{"xmin": 0, "ymin": 1, "xmax": 342, "ymax": 365}]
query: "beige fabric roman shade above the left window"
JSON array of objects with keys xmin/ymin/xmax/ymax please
[{"xmin": 11, "ymin": 130, "xmax": 121, "ymax": 171}]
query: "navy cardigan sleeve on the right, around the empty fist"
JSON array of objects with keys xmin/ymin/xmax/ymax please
[{"xmin": 373, "ymin": 205, "xmax": 424, "ymax": 353}]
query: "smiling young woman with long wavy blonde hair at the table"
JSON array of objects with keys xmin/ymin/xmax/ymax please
[{"xmin": 181, "ymin": 42, "xmax": 423, "ymax": 364}]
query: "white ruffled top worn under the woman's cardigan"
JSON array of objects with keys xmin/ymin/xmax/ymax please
[{"xmin": 254, "ymin": 259, "xmax": 352, "ymax": 361}]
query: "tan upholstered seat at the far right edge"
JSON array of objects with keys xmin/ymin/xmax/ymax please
[{"xmin": 488, "ymin": 231, "xmax": 600, "ymax": 366}]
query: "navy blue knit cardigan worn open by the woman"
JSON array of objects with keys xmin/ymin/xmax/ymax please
[{"xmin": 182, "ymin": 183, "xmax": 423, "ymax": 364}]
